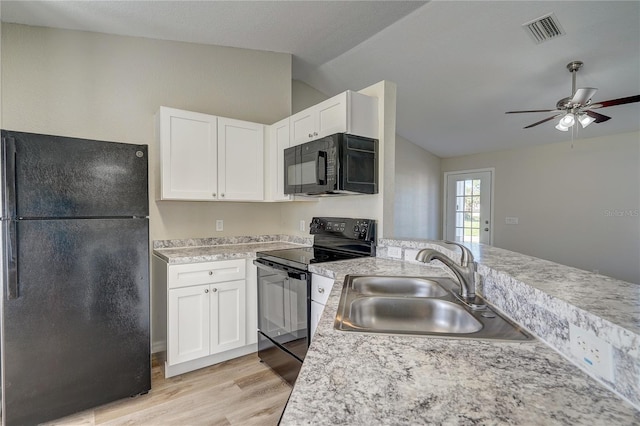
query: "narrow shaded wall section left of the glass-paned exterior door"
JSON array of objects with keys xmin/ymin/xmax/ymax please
[{"xmin": 393, "ymin": 136, "xmax": 442, "ymax": 240}]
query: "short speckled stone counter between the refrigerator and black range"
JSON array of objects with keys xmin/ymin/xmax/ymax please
[{"xmin": 153, "ymin": 235, "xmax": 313, "ymax": 264}]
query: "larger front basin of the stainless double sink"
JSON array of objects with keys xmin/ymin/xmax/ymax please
[{"xmin": 349, "ymin": 297, "xmax": 482, "ymax": 334}]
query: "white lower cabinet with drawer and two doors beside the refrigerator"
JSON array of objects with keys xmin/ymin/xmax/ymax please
[{"xmin": 154, "ymin": 258, "xmax": 257, "ymax": 377}]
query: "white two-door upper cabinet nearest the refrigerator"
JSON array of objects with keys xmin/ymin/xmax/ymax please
[{"xmin": 157, "ymin": 107, "xmax": 264, "ymax": 201}]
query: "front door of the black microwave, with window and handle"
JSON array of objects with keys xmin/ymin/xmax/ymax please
[{"xmin": 284, "ymin": 136, "xmax": 337, "ymax": 194}]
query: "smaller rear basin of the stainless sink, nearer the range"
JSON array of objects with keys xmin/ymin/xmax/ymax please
[{"xmin": 352, "ymin": 276, "xmax": 447, "ymax": 297}]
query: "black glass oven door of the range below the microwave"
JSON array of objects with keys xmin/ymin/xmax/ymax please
[{"xmin": 254, "ymin": 259, "xmax": 310, "ymax": 361}]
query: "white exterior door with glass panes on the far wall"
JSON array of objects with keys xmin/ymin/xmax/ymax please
[{"xmin": 444, "ymin": 170, "xmax": 493, "ymax": 244}]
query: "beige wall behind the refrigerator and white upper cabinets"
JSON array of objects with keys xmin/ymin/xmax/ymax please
[{"xmin": 2, "ymin": 24, "xmax": 291, "ymax": 240}]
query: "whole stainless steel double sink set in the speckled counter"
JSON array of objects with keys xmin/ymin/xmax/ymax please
[{"xmin": 334, "ymin": 275, "xmax": 533, "ymax": 341}]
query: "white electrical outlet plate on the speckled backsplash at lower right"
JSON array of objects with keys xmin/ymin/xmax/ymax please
[{"xmin": 569, "ymin": 324, "xmax": 613, "ymax": 382}]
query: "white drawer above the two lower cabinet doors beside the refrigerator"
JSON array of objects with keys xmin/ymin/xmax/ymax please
[{"xmin": 169, "ymin": 259, "xmax": 246, "ymax": 288}]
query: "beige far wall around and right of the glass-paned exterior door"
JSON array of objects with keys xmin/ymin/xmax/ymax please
[{"xmin": 442, "ymin": 132, "xmax": 640, "ymax": 283}]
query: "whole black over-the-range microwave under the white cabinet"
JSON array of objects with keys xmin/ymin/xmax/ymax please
[{"xmin": 284, "ymin": 133, "xmax": 378, "ymax": 195}]
